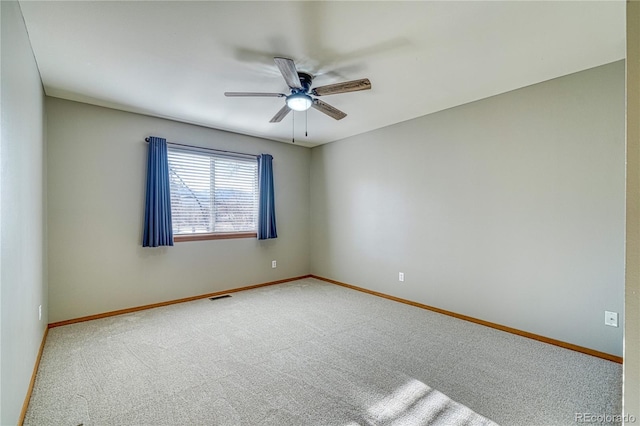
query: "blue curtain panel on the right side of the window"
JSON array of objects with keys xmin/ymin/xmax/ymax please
[{"xmin": 258, "ymin": 154, "xmax": 278, "ymax": 240}]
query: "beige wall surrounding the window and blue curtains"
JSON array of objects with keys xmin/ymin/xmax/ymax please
[{"xmin": 46, "ymin": 98, "xmax": 310, "ymax": 322}]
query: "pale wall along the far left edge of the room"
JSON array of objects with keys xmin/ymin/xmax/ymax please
[{"xmin": 0, "ymin": 1, "xmax": 47, "ymax": 425}]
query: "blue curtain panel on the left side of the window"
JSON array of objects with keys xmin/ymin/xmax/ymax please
[{"xmin": 142, "ymin": 136, "xmax": 173, "ymax": 247}]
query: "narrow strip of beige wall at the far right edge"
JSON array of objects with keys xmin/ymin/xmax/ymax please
[{"xmin": 623, "ymin": 1, "xmax": 640, "ymax": 424}]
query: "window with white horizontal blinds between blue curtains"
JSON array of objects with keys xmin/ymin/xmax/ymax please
[{"xmin": 167, "ymin": 146, "xmax": 258, "ymax": 241}]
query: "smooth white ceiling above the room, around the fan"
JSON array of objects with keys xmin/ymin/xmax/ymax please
[{"xmin": 20, "ymin": 1, "xmax": 625, "ymax": 146}]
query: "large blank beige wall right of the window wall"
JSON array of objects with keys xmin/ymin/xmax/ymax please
[{"xmin": 311, "ymin": 62, "xmax": 625, "ymax": 355}]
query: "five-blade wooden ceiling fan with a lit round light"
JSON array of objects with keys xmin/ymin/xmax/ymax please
[{"xmin": 224, "ymin": 58, "xmax": 371, "ymax": 123}]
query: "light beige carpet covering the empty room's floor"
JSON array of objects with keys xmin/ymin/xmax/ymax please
[{"xmin": 25, "ymin": 279, "xmax": 622, "ymax": 426}]
